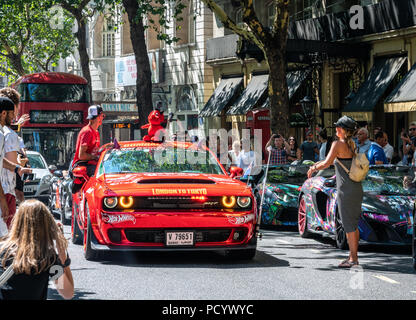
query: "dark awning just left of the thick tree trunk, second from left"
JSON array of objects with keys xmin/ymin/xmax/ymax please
[{"xmin": 227, "ymin": 74, "xmax": 269, "ymax": 115}]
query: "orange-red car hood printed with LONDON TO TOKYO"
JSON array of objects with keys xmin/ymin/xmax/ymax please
[{"xmin": 98, "ymin": 173, "xmax": 251, "ymax": 196}]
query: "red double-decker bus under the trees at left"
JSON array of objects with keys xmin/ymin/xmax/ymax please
[{"xmin": 12, "ymin": 72, "xmax": 90, "ymax": 169}]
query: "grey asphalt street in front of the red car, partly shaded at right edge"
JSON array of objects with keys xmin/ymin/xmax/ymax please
[{"xmin": 48, "ymin": 226, "xmax": 416, "ymax": 300}]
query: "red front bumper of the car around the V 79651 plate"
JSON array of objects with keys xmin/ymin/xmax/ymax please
[{"xmin": 91, "ymin": 212, "xmax": 257, "ymax": 251}]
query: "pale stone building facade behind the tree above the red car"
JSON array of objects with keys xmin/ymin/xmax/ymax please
[{"xmin": 89, "ymin": 0, "xmax": 212, "ymax": 141}]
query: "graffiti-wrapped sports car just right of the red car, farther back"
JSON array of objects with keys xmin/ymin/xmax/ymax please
[{"xmin": 254, "ymin": 165, "xmax": 309, "ymax": 226}]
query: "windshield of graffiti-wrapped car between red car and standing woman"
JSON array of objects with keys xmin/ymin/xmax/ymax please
[{"xmin": 267, "ymin": 165, "xmax": 309, "ymax": 185}]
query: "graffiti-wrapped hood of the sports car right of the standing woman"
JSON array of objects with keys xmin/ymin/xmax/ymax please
[{"xmin": 362, "ymin": 194, "xmax": 416, "ymax": 220}]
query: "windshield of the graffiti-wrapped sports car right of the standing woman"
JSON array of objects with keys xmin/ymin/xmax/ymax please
[{"xmin": 363, "ymin": 166, "xmax": 416, "ymax": 196}]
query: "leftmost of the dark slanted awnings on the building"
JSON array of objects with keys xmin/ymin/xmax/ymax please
[{"xmin": 199, "ymin": 77, "xmax": 243, "ymax": 117}]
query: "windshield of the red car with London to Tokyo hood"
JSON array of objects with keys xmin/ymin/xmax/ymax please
[{"xmin": 99, "ymin": 145, "xmax": 224, "ymax": 174}]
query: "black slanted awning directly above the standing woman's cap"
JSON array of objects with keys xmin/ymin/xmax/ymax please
[{"xmin": 343, "ymin": 57, "xmax": 406, "ymax": 112}]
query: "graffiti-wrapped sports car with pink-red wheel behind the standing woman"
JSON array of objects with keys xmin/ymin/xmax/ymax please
[{"xmin": 298, "ymin": 165, "xmax": 415, "ymax": 249}]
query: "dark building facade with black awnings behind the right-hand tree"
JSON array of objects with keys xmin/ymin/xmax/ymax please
[{"xmin": 200, "ymin": 0, "xmax": 416, "ymax": 158}]
